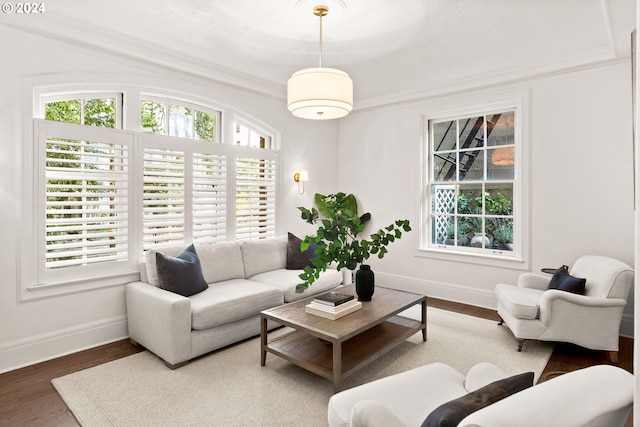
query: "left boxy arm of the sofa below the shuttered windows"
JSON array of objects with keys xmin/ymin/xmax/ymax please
[{"xmin": 126, "ymin": 282, "xmax": 191, "ymax": 367}]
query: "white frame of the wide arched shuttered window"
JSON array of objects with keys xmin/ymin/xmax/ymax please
[{"xmin": 16, "ymin": 85, "xmax": 282, "ymax": 302}]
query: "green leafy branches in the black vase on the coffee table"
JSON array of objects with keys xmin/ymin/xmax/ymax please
[{"xmin": 296, "ymin": 193, "xmax": 411, "ymax": 293}]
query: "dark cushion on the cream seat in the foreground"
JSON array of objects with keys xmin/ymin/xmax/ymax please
[{"xmin": 422, "ymin": 372, "xmax": 534, "ymax": 427}]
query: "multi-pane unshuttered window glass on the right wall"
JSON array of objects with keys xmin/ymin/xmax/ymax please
[{"xmin": 426, "ymin": 110, "xmax": 519, "ymax": 257}]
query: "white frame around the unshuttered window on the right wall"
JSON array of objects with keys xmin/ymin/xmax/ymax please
[{"xmin": 416, "ymin": 90, "xmax": 530, "ymax": 270}]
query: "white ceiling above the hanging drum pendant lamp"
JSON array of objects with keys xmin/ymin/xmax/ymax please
[{"xmin": 0, "ymin": 0, "xmax": 635, "ymax": 109}]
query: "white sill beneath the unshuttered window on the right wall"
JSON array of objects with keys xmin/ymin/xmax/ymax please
[{"xmin": 415, "ymin": 246, "xmax": 529, "ymax": 271}]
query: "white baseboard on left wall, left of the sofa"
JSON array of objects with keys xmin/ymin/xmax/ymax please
[{"xmin": 0, "ymin": 316, "xmax": 129, "ymax": 374}]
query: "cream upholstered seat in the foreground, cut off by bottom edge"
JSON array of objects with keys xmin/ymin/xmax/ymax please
[{"xmin": 328, "ymin": 363, "xmax": 634, "ymax": 427}]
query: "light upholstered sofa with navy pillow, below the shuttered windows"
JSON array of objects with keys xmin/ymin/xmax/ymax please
[{"xmin": 126, "ymin": 236, "xmax": 342, "ymax": 369}]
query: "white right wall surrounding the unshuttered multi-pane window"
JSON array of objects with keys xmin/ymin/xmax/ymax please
[{"xmin": 339, "ymin": 60, "xmax": 634, "ymax": 336}]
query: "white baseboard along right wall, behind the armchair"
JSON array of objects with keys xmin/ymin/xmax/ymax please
[{"xmin": 376, "ymin": 271, "xmax": 634, "ymax": 338}]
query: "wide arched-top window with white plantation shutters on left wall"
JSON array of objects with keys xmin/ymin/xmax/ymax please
[{"xmin": 26, "ymin": 93, "xmax": 279, "ymax": 294}]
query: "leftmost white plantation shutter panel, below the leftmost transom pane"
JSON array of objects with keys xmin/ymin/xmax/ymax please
[{"xmin": 38, "ymin": 122, "xmax": 132, "ymax": 284}]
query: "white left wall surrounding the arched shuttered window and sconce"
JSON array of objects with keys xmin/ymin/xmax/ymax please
[{"xmin": 0, "ymin": 27, "xmax": 338, "ymax": 372}]
